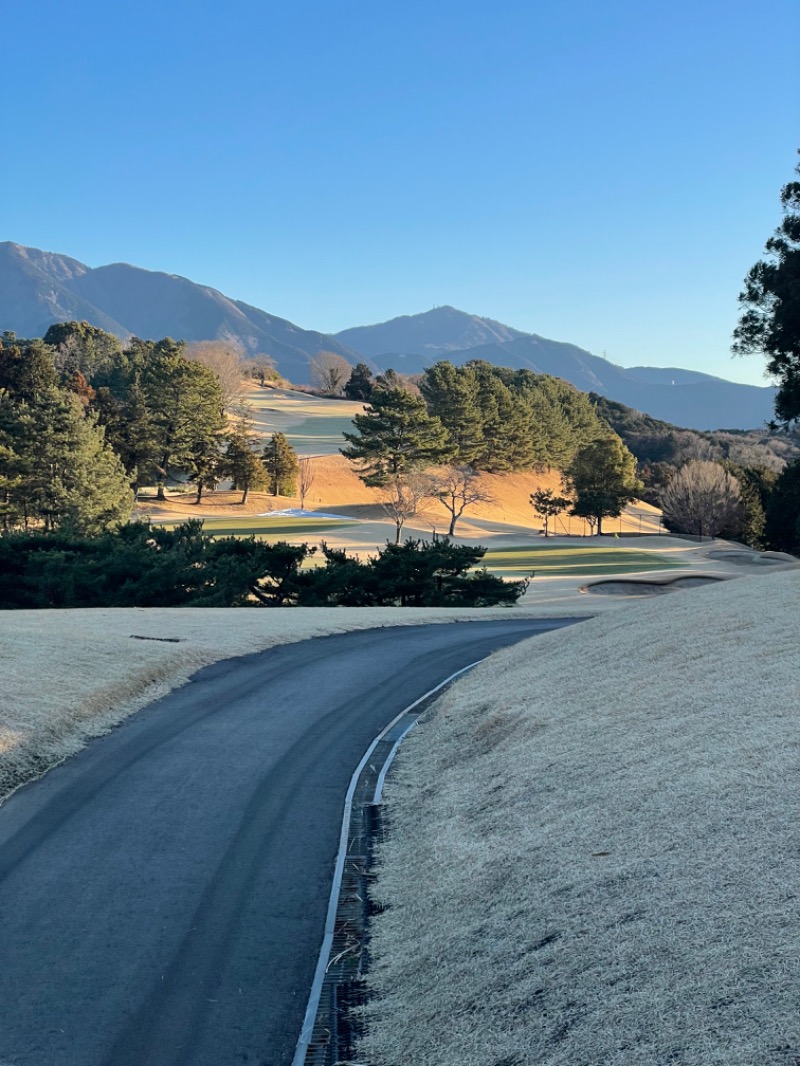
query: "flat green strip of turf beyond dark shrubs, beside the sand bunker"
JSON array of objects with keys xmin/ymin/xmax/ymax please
[{"xmin": 483, "ymin": 544, "xmax": 681, "ymax": 577}]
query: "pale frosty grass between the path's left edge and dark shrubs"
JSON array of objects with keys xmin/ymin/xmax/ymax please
[{"xmin": 0, "ymin": 608, "xmax": 571, "ymax": 800}]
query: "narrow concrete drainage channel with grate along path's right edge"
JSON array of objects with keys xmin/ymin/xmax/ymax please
[{"xmin": 292, "ymin": 663, "xmax": 477, "ymax": 1066}]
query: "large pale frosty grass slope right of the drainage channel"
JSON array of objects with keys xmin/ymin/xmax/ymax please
[{"xmin": 358, "ymin": 569, "xmax": 800, "ymax": 1066}]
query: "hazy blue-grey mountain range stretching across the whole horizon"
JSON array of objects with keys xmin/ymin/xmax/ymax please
[{"xmin": 0, "ymin": 242, "xmax": 775, "ymax": 430}]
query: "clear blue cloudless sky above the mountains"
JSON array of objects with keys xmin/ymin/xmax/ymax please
[{"xmin": 0, "ymin": 0, "xmax": 800, "ymax": 384}]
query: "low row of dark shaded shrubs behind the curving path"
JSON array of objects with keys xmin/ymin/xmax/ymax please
[{"xmin": 0, "ymin": 519, "xmax": 527, "ymax": 610}]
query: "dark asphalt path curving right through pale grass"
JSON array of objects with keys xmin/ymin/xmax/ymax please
[{"xmin": 0, "ymin": 619, "xmax": 569, "ymax": 1066}]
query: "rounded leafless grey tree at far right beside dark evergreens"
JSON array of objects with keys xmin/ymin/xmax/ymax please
[{"xmin": 661, "ymin": 459, "xmax": 743, "ymax": 537}]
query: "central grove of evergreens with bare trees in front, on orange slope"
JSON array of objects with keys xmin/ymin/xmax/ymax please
[{"xmin": 341, "ymin": 360, "xmax": 641, "ymax": 542}]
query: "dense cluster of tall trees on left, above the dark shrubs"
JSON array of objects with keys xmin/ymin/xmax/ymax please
[{"xmin": 0, "ymin": 322, "xmax": 301, "ymax": 534}]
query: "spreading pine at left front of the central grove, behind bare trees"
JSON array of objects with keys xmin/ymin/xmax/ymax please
[{"xmin": 340, "ymin": 389, "xmax": 448, "ymax": 486}]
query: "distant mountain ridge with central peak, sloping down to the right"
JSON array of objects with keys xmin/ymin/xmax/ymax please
[{"xmin": 336, "ymin": 307, "xmax": 775, "ymax": 430}]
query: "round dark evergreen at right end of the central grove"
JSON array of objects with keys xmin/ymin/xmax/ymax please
[{"xmin": 565, "ymin": 437, "xmax": 642, "ymax": 536}]
